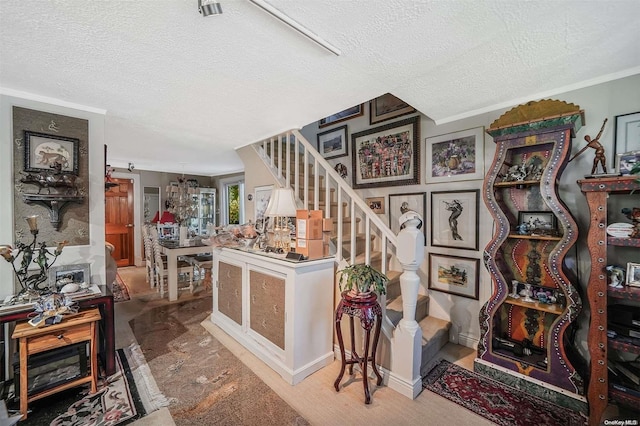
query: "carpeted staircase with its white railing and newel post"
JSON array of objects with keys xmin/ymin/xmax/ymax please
[{"xmin": 254, "ymin": 130, "xmax": 451, "ymax": 398}]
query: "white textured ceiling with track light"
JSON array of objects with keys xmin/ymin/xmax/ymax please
[{"xmin": 0, "ymin": 0, "xmax": 640, "ymax": 175}]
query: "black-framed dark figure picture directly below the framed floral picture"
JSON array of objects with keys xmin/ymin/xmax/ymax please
[{"xmin": 431, "ymin": 189, "xmax": 480, "ymax": 250}]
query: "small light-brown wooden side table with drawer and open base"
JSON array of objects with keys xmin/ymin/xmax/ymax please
[{"xmin": 11, "ymin": 308, "xmax": 101, "ymax": 419}]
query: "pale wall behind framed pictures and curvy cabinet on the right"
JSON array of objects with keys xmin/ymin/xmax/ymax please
[{"xmin": 298, "ymin": 75, "xmax": 640, "ymax": 354}]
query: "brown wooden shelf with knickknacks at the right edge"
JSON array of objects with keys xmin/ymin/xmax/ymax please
[{"xmin": 578, "ymin": 175, "xmax": 640, "ymax": 425}]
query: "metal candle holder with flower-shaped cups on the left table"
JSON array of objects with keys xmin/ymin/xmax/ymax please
[{"xmin": 0, "ymin": 215, "xmax": 68, "ymax": 302}]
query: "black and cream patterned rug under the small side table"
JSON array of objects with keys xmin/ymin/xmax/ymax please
[{"xmin": 19, "ymin": 349, "xmax": 150, "ymax": 426}]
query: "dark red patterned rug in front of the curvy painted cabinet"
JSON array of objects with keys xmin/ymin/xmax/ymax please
[{"xmin": 422, "ymin": 360, "xmax": 587, "ymax": 426}]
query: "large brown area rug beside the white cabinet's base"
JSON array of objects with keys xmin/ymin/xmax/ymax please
[{"xmin": 129, "ymin": 294, "xmax": 309, "ymax": 426}]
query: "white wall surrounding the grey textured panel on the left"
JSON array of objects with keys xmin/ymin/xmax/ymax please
[{"xmin": 0, "ymin": 88, "xmax": 106, "ymax": 298}]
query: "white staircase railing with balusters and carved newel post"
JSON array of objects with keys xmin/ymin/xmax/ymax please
[{"xmin": 254, "ymin": 130, "xmax": 422, "ymax": 398}]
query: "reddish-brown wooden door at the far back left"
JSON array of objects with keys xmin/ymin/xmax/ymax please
[{"xmin": 104, "ymin": 178, "xmax": 135, "ymax": 267}]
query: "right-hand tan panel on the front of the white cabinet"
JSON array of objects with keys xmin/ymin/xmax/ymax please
[{"xmin": 249, "ymin": 270, "xmax": 285, "ymax": 349}]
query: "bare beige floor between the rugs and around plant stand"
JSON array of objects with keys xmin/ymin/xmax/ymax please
[{"xmin": 116, "ymin": 268, "xmax": 492, "ymax": 426}]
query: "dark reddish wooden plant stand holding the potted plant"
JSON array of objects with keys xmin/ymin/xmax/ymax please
[{"xmin": 333, "ymin": 291, "xmax": 382, "ymax": 404}]
